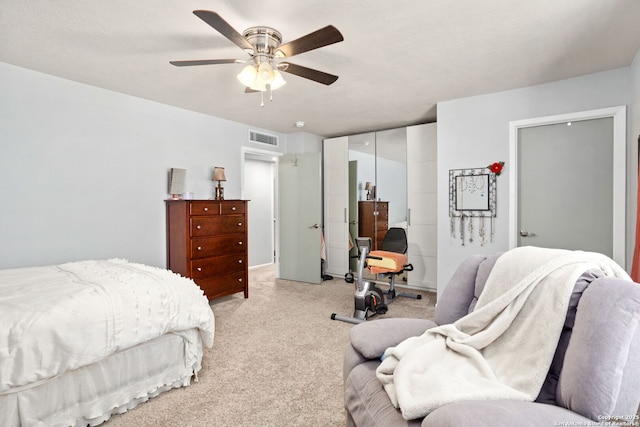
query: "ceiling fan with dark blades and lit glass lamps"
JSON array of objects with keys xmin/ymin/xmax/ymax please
[{"xmin": 170, "ymin": 10, "xmax": 344, "ymax": 102}]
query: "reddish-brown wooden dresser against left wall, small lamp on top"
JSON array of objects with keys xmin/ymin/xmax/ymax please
[{"xmin": 166, "ymin": 200, "xmax": 249, "ymax": 300}]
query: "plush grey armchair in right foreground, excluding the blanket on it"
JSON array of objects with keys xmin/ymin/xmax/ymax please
[{"xmin": 344, "ymin": 254, "xmax": 640, "ymax": 427}]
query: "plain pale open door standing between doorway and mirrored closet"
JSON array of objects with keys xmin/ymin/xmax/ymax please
[{"xmin": 278, "ymin": 153, "xmax": 322, "ymax": 284}]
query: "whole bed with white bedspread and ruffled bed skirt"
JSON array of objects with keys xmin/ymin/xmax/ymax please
[{"xmin": 0, "ymin": 259, "xmax": 214, "ymax": 427}]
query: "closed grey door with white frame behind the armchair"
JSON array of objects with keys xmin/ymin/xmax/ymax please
[{"xmin": 508, "ymin": 107, "xmax": 625, "ymax": 266}]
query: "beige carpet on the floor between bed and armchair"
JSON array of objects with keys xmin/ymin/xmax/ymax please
[{"xmin": 104, "ymin": 266, "xmax": 435, "ymax": 427}]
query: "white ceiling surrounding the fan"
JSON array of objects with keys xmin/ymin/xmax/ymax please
[{"xmin": 0, "ymin": 0, "xmax": 640, "ymax": 137}]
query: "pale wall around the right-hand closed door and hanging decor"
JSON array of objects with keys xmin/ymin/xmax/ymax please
[{"xmin": 438, "ymin": 67, "xmax": 637, "ymax": 294}]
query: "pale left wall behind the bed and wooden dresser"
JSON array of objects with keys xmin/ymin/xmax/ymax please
[{"xmin": 0, "ymin": 63, "xmax": 287, "ymax": 268}]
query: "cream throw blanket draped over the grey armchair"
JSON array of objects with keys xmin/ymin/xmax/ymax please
[{"xmin": 377, "ymin": 247, "xmax": 629, "ymax": 419}]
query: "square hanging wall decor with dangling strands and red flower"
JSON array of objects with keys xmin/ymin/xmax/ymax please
[{"xmin": 449, "ymin": 167, "xmax": 504, "ymax": 246}]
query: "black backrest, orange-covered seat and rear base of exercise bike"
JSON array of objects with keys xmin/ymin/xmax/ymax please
[{"xmin": 368, "ymin": 227, "xmax": 422, "ymax": 303}]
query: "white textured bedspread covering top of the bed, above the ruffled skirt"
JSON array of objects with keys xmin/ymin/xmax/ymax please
[{"xmin": 0, "ymin": 259, "xmax": 214, "ymax": 394}]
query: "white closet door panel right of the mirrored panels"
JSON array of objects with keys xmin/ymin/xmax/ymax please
[{"xmin": 407, "ymin": 123, "xmax": 438, "ymax": 291}]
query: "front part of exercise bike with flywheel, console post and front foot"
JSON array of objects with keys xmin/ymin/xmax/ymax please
[{"xmin": 331, "ymin": 237, "xmax": 388, "ymax": 323}]
